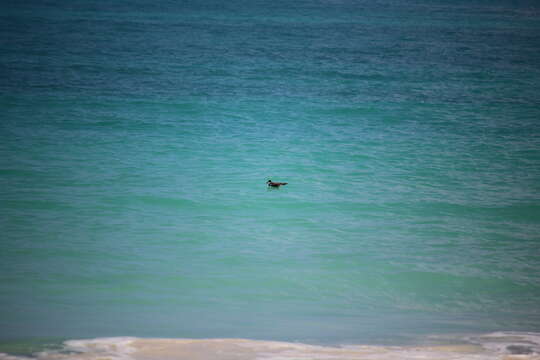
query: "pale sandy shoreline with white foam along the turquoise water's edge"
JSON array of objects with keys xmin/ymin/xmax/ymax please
[{"xmin": 0, "ymin": 332, "xmax": 540, "ymax": 360}]
